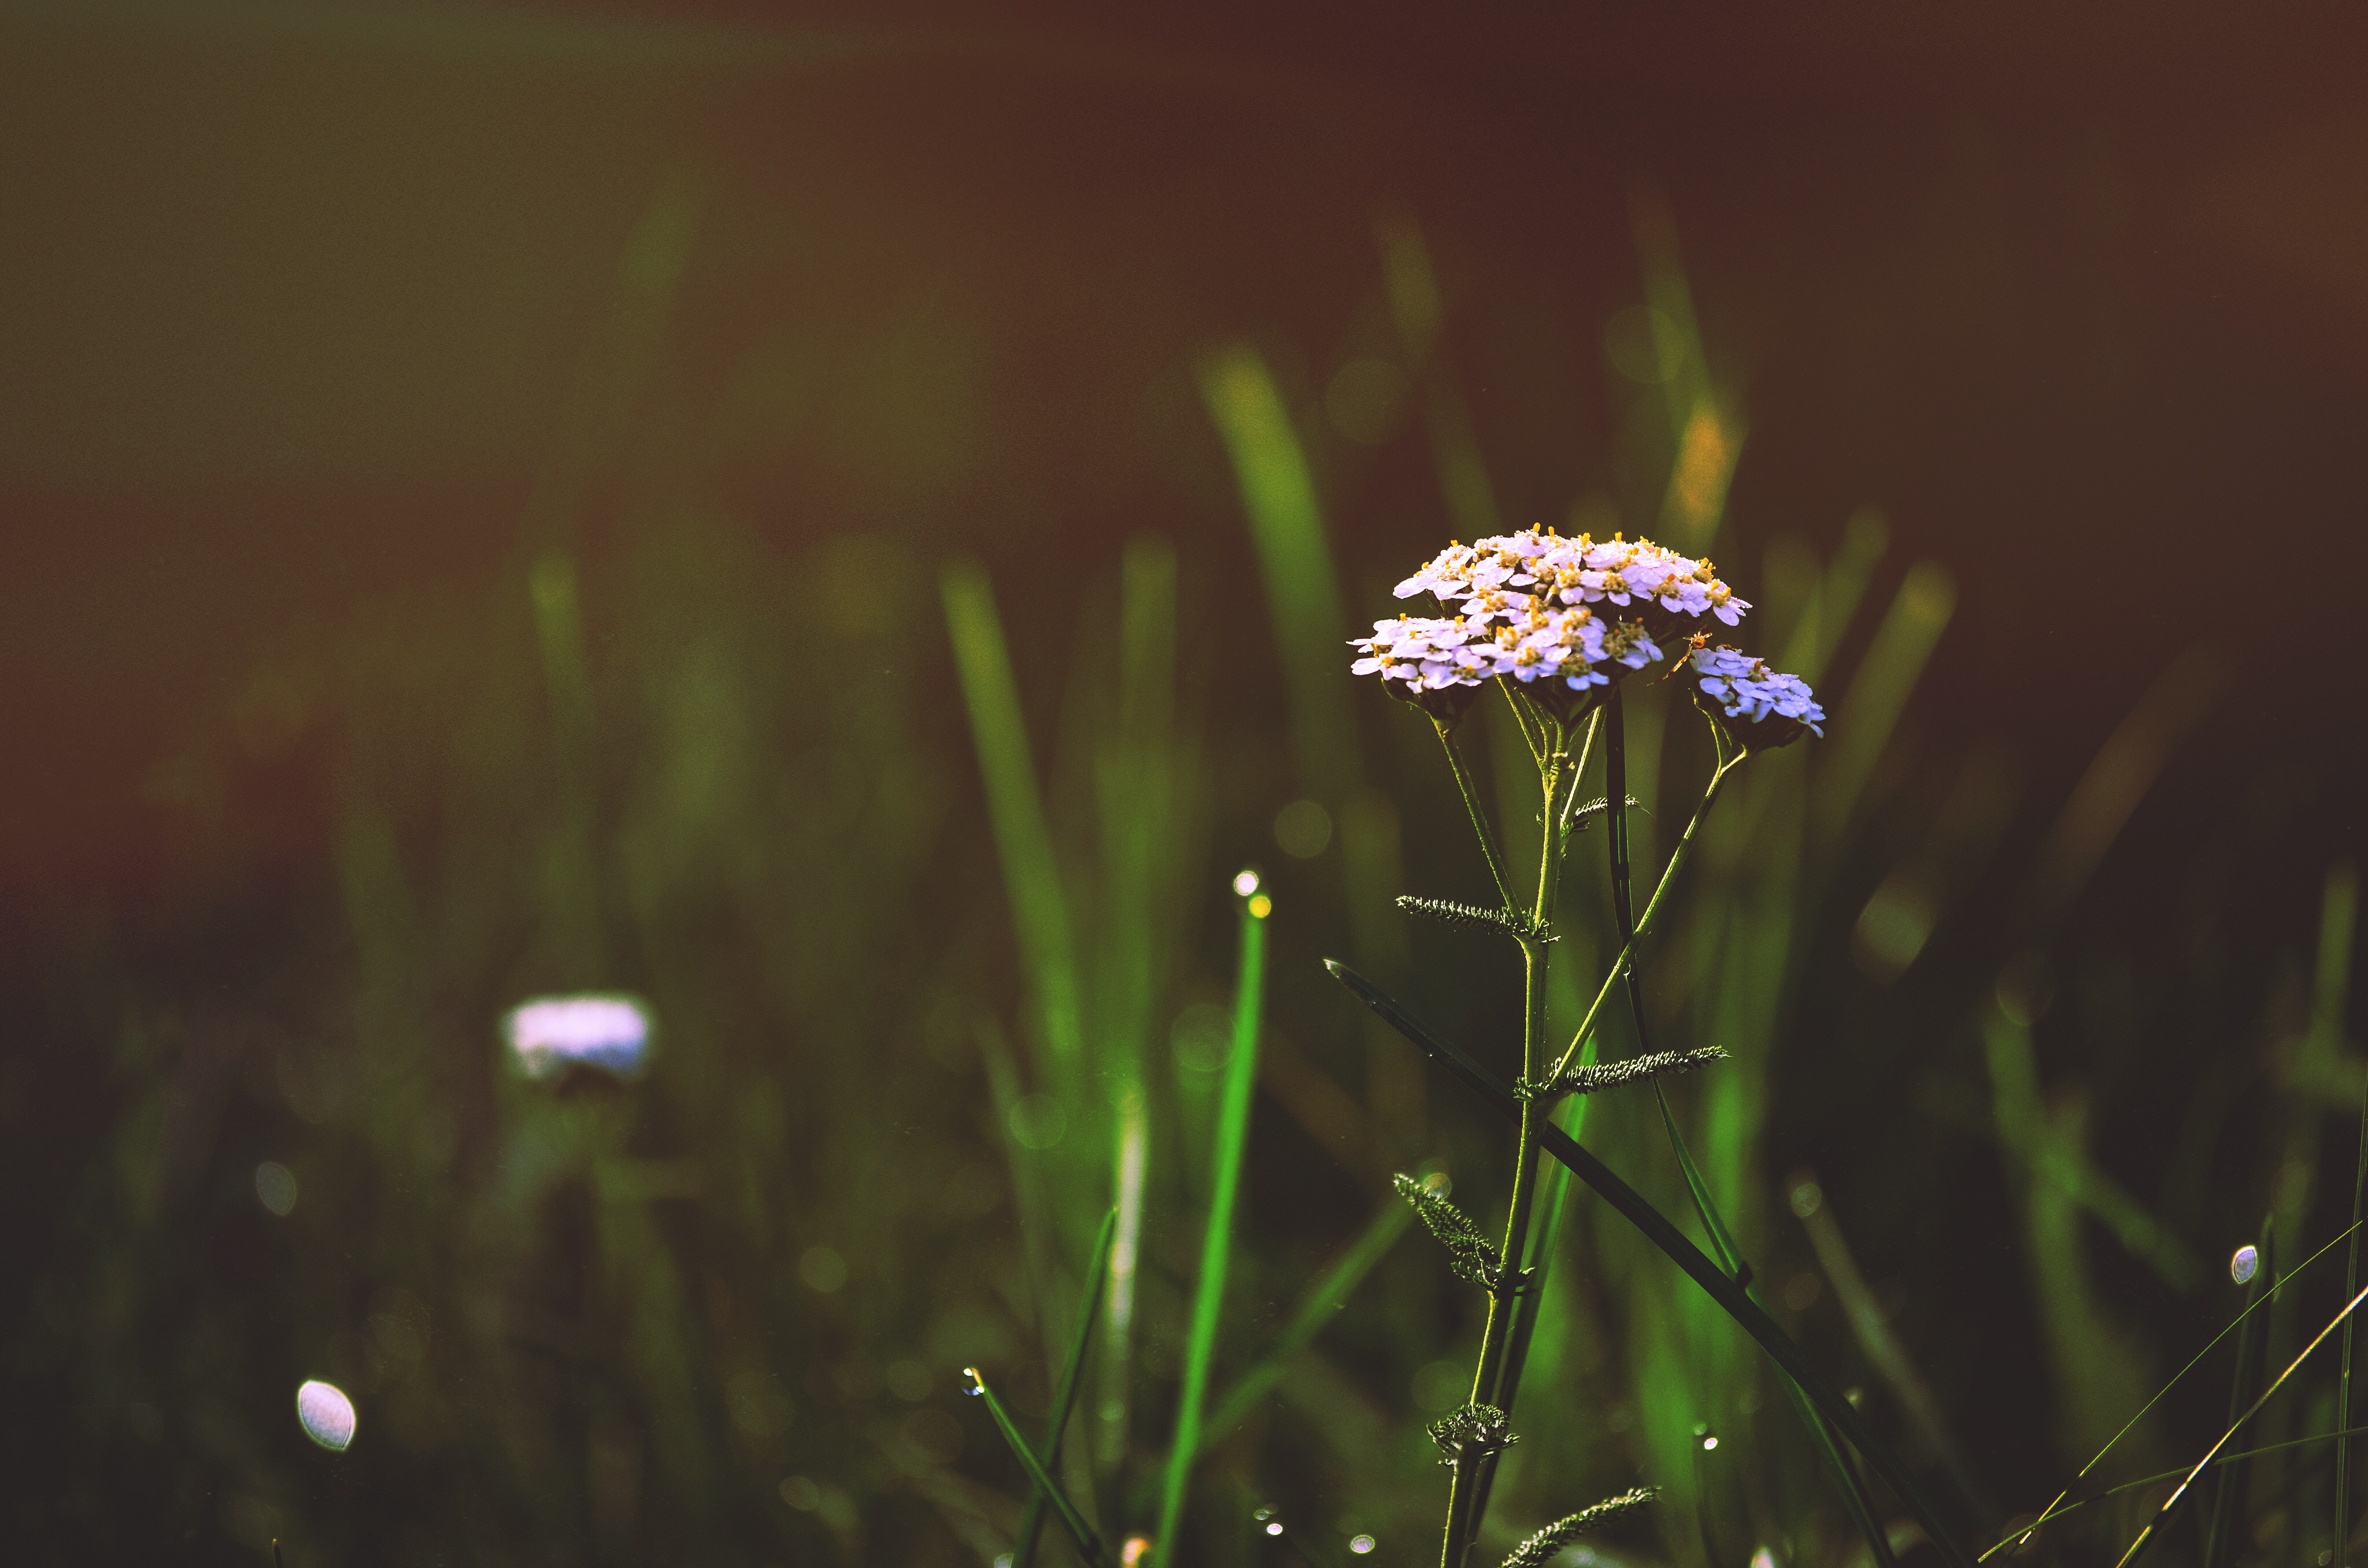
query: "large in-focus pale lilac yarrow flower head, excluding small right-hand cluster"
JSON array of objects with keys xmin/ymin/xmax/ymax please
[{"xmin": 1350, "ymin": 528, "xmax": 1750, "ymax": 718}]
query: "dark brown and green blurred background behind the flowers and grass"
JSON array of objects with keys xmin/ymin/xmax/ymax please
[{"xmin": 0, "ymin": 5, "xmax": 2368, "ymax": 1563}]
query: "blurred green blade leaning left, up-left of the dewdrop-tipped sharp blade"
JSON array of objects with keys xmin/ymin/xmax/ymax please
[{"xmin": 938, "ymin": 557, "xmax": 1085, "ymax": 1068}]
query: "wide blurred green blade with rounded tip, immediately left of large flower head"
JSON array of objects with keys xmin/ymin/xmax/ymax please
[{"xmin": 1201, "ymin": 346, "xmax": 1357, "ymax": 810}]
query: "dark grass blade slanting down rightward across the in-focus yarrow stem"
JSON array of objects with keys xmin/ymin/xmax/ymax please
[{"xmin": 1324, "ymin": 959, "xmax": 1973, "ymax": 1568}]
